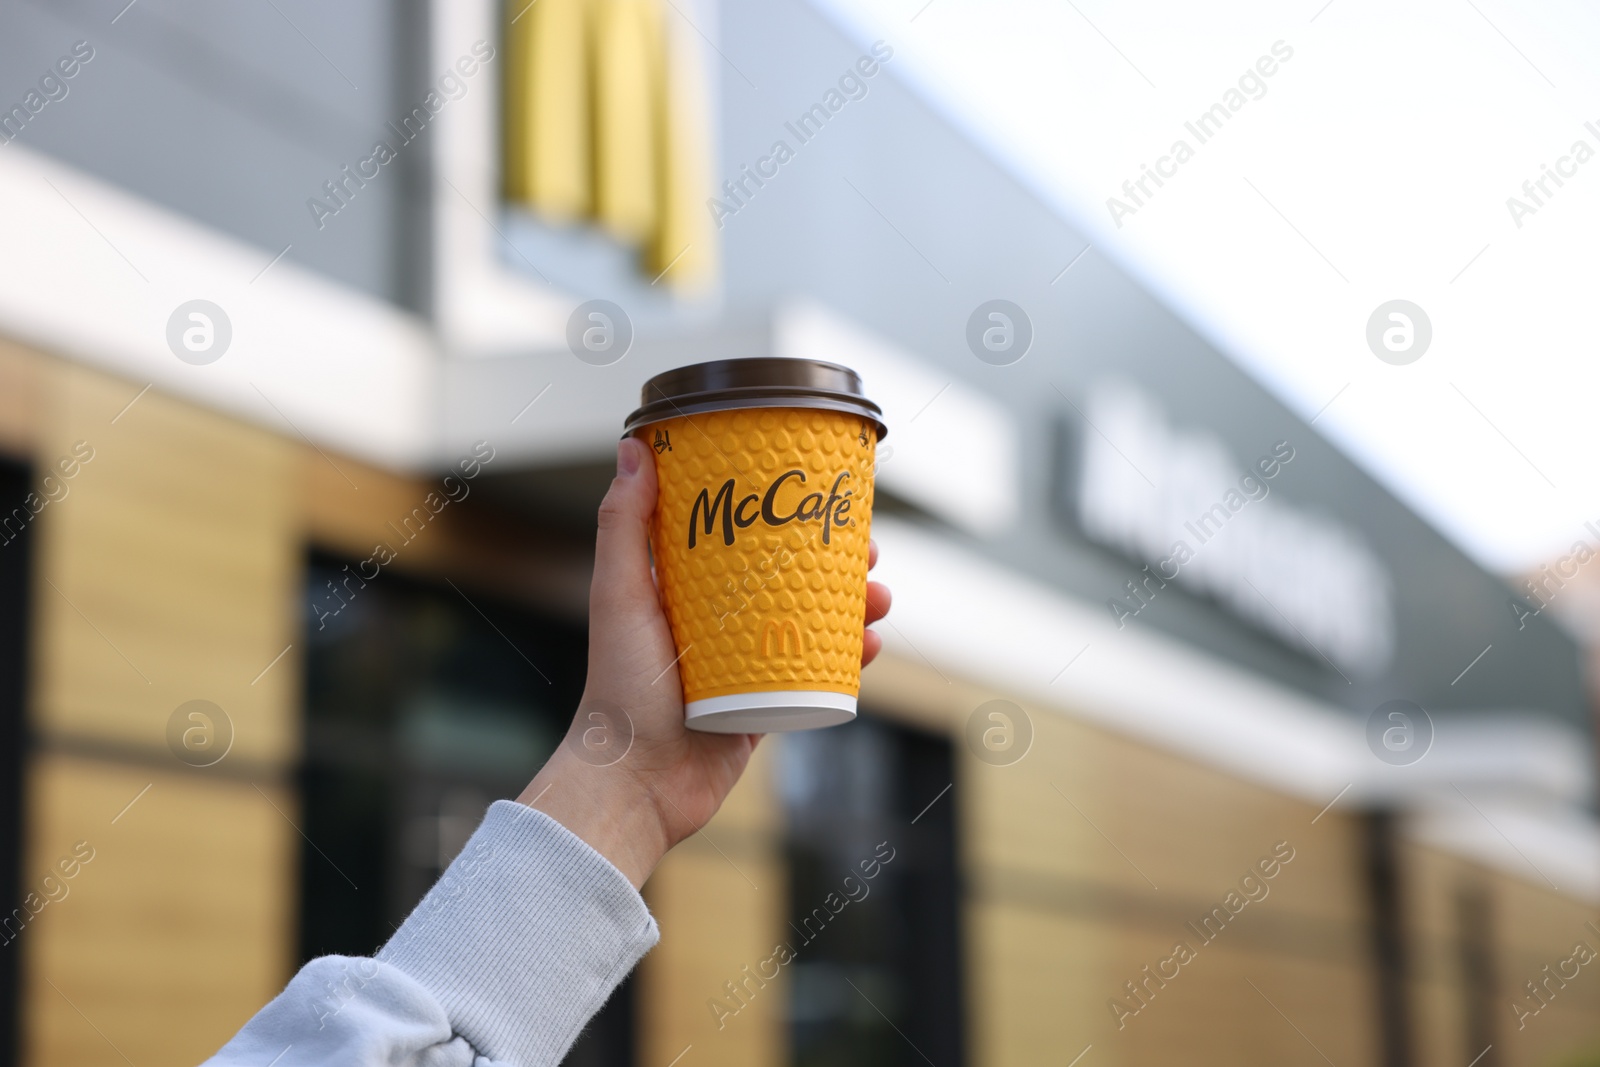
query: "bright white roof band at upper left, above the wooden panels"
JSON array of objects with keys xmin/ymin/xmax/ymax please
[{"xmin": 0, "ymin": 144, "xmax": 438, "ymax": 469}]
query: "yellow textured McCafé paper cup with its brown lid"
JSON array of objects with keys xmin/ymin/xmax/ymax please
[{"xmin": 626, "ymin": 358, "xmax": 888, "ymax": 733}]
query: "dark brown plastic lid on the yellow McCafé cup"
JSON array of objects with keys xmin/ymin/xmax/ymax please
[{"xmin": 622, "ymin": 357, "xmax": 890, "ymax": 440}]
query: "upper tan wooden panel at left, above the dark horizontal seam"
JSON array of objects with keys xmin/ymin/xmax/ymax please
[{"xmin": 34, "ymin": 365, "xmax": 301, "ymax": 765}]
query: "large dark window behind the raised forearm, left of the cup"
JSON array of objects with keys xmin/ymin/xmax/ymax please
[{"xmin": 299, "ymin": 555, "xmax": 634, "ymax": 1067}]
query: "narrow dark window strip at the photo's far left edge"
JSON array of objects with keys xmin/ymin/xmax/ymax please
[{"xmin": 0, "ymin": 462, "xmax": 34, "ymax": 1067}]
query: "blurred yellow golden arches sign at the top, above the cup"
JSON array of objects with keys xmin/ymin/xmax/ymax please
[{"xmin": 504, "ymin": 0, "xmax": 717, "ymax": 291}]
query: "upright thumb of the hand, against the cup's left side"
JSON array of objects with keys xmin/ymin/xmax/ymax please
[{"xmin": 589, "ymin": 437, "xmax": 659, "ymax": 619}]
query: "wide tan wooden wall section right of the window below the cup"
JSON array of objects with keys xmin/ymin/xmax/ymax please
[{"xmin": 864, "ymin": 657, "xmax": 1376, "ymax": 1067}]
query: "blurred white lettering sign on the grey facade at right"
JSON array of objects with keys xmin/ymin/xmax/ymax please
[{"xmin": 1067, "ymin": 379, "xmax": 1395, "ymax": 677}]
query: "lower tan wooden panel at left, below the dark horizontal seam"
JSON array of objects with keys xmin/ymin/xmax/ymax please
[{"xmin": 13, "ymin": 755, "xmax": 299, "ymax": 1067}]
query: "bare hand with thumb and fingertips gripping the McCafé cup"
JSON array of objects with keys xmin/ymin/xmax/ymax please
[{"xmin": 517, "ymin": 438, "xmax": 890, "ymax": 888}]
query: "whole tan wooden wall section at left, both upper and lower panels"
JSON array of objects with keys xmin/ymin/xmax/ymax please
[{"xmin": 16, "ymin": 360, "xmax": 302, "ymax": 1067}]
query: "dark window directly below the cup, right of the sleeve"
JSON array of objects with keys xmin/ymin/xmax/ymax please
[{"xmin": 779, "ymin": 718, "xmax": 963, "ymax": 1067}]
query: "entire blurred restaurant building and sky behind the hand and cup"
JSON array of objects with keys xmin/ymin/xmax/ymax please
[{"xmin": 0, "ymin": 0, "xmax": 1600, "ymax": 1067}]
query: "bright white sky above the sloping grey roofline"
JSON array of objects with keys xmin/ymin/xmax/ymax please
[{"xmin": 814, "ymin": 0, "xmax": 1600, "ymax": 573}]
